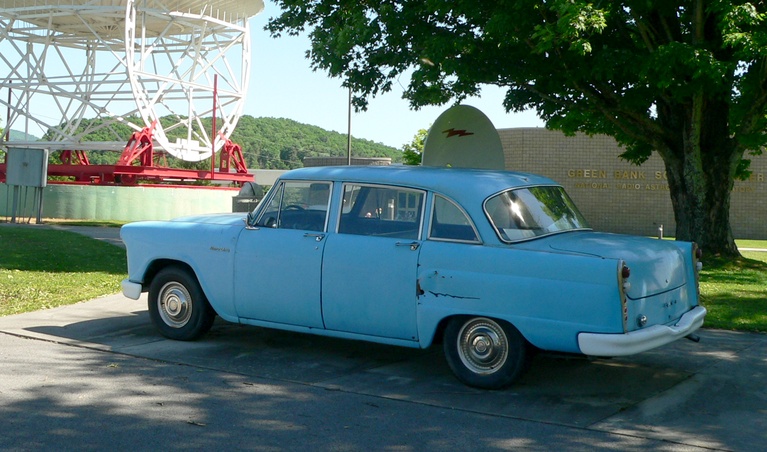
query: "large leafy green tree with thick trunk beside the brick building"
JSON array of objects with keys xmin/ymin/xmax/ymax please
[{"xmin": 267, "ymin": 0, "xmax": 767, "ymax": 255}]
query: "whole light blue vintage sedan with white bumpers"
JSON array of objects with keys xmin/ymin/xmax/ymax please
[{"xmin": 121, "ymin": 166, "xmax": 706, "ymax": 388}]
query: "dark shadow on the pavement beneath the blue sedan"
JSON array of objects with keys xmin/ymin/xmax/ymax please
[{"xmin": 19, "ymin": 302, "xmax": 736, "ymax": 427}]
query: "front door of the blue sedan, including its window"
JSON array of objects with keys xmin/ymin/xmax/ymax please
[{"xmin": 235, "ymin": 181, "xmax": 331, "ymax": 328}]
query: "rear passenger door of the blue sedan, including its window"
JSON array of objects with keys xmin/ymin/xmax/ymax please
[{"xmin": 322, "ymin": 184, "xmax": 425, "ymax": 341}]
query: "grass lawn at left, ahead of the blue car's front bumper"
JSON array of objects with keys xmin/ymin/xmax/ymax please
[{"xmin": 0, "ymin": 225, "xmax": 127, "ymax": 316}]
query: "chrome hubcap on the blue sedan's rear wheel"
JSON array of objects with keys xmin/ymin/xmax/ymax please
[{"xmin": 458, "ymin": 318, "xmax": 509, "ymax": 375}]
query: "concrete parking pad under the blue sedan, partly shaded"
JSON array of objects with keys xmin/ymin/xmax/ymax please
[{"xmin": 0, "ymin": 295, "xmax": 767, "ymax": 450}]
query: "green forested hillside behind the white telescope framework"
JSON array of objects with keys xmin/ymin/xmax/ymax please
[{"xmin": 20, "ymin": 116, "xmax": 402, "ymax": 169}]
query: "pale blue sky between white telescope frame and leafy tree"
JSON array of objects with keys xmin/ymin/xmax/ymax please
[{"xmin": 243, "ymin": 1, "xmax": 543, "ymax": 148}]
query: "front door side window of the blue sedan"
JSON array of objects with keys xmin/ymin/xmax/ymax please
[{"xmin": 257, "ymin": 181, "xmax": 330, "ymax": 232}]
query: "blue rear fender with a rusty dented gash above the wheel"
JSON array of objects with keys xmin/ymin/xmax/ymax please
[{"xmin": 417, "ymin": 242, "xmax": 623, "ymax": 352}]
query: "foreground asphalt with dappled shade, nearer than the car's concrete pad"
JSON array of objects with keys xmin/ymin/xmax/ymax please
[{"xmin": 0, "ymin": 333, "xmax": 694, "ymax": 452}]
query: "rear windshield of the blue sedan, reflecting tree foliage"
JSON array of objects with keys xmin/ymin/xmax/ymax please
[{"xmin": 485, "ymin": 186, "xmax": 589, "ymax": 242}]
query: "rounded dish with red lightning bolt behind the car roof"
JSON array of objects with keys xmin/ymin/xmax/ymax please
[{"xmin": 423, "ymin": 105, "xmax": 506, "ymax": 170}]
